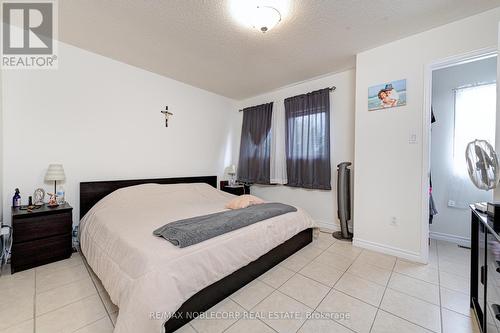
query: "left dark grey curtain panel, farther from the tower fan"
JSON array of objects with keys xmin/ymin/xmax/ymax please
[{"xmin": 238, "ymin": 103, "xmax": 273, "ymax": 184}]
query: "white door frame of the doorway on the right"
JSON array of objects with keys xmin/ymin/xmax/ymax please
[{"xmin": 421, "ymin": 45, "xmax": 500, "ymax": 256}]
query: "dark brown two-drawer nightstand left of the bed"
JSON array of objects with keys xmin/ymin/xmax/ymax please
[{"xmin": 10, "ymin": 203, "xmax": 73, "ymax": 274}]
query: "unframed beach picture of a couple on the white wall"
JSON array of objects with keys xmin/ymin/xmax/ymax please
[{"xmin": 368, "ymin": 79, "xmax": 406, "ymax": 111}]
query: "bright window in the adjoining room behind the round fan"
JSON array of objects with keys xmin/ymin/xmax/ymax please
[{"xmin": 453, "ymin": 84, "xmax": 496, "ymax": 177}]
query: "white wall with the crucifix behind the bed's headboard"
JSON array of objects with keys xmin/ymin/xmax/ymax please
[{"xmin": 3, "ymin": 43, "xmax": 237, "ymax": 223}]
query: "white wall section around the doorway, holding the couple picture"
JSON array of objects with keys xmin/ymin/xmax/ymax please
[{"xmin": 354, "ymin": 8, "xmax": 500, "ymax": 261}]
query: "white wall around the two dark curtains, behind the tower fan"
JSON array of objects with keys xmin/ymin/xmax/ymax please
[{"xmin": 235, "ymin": 69, "xmax": 355, "ymax": 230}]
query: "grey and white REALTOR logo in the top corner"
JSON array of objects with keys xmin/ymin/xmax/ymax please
[{"xmin": 2, "ymin": 1, "xmax": 57, "ymax": 69}]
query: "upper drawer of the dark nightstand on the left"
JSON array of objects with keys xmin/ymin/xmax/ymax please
[{"xmin": 12, "ymin": 211, "xmax": 73, "ymax": 244}]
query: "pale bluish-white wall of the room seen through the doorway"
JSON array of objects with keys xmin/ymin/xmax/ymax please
[{"xmin": 430, "ymin": 57, "xmax": 497, "ymax": 244}]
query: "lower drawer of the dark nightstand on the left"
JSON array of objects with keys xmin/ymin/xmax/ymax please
[{"xmin": 11, "ymin": 233, "xmax": 72, "ymax": 273}]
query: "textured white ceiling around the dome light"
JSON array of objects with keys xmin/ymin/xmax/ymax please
[{"xmin": 59, "ymin": 0, "xmax": 500, "ymax": 99}]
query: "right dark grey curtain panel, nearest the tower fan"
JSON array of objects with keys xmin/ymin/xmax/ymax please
[{"xmin": 285, "ymin": 88, "xmax": 331, "ymax": 190}]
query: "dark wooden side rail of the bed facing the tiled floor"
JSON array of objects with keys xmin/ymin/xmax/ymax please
[{"xmin": 164, "ymin": 229, "xmax": 313, "ymax": 333}]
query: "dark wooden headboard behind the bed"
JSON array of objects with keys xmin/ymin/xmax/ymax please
[{"xmin": 80, "ymin": 176, "xmax": 217, "ymax": 219}]
